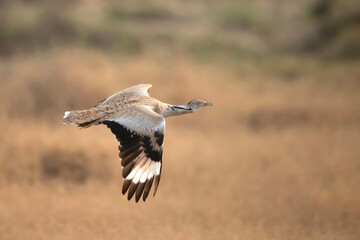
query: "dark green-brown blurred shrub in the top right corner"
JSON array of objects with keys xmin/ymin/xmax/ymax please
[{"xmin": 305, "ymin": 0, "xmax": 360, "ymax": 58}]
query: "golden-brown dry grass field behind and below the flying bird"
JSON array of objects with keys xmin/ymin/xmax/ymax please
[{"xmin": 0, "ymin": 49, "xmax": 360, "ymax": 240}]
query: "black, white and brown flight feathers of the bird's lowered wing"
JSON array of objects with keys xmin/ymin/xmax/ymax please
[{"xmin": 102, "ymin": 121, "xmax": 164, "ymax": 202}]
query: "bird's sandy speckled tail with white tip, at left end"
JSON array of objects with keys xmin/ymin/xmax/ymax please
[{"xmin": 63, "ymin": 108, "xmax": 104, "ymax": 128}]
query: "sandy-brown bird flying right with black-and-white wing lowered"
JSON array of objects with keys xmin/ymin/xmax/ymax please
[{"xmin": 63, "ymin": 84, "xmax": 213, "ymax": 202}]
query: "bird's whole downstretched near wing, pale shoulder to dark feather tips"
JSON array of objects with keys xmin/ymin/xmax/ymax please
[{"xmin": 102, "ymin": 106, "xmax": 165, "ymax": 202}]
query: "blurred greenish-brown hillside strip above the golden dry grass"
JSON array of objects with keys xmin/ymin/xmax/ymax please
[{"xmin": 0, "ymin": 0, "xmax": 360, "ymax": 59}]
